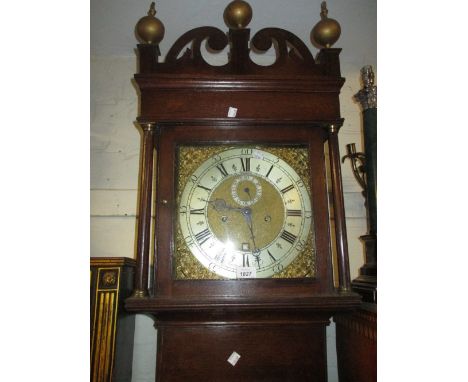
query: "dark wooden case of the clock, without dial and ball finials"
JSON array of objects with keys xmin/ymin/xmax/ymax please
[{"xmin": 126, "ymin": 15, "xmax": 359, "ymax": 382}]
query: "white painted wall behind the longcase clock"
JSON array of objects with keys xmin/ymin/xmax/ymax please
[{"xmin": 91, "ymin": 0, "xmax": 377, "ymax": 382}]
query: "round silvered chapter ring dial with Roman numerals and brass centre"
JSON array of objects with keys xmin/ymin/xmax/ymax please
[{"xmin": 179, "ymin": 147, "xmax": 312, "ymax": 278}]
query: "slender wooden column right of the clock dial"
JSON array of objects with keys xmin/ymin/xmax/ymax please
[{"xmin": 328, "ymin": 125, "xmax": 350, "ymax": 292}]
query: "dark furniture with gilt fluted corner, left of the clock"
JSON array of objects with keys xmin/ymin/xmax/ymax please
[{"xmin": 90, "ymin": 257, "xmax": 135, "ymax": 382}]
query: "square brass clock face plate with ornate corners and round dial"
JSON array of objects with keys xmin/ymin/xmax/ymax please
[{"xmin": 173, "ymin": 145, "xmax": 315, "ymax": 279}]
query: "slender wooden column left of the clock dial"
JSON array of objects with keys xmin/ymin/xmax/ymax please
[{"xmin": 132, "ymin": 123, "xmax": 157, "ymax": 298}]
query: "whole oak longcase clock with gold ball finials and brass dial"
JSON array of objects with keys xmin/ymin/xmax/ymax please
[{"xmin": 126, "ymin": 0, "xmax": 359, "ymax": 381}]
